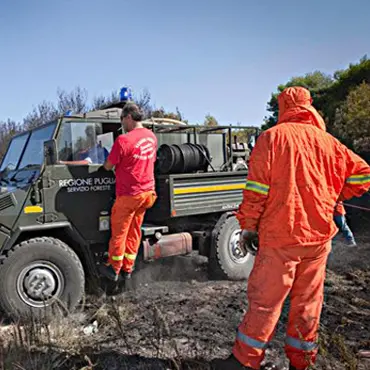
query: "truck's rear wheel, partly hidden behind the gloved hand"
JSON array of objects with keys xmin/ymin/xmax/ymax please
[{"xmin": 209, "ymin": 216, "xmax": 254, "ymax": 280}]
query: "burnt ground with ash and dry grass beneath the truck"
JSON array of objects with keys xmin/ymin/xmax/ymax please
[{"xmin": 0, "ymin": 221, "xmax": 370, "ymax": 370}]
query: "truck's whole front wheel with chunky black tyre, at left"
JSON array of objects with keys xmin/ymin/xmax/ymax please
[{"xmin": 0, "ymin": 237, "xmax": 85, "ymax": 320}]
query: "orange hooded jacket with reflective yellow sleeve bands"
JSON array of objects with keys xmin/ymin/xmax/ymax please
[{"xmin": 237, "ymin": 87, "xmax": 370, "ymax": 248}]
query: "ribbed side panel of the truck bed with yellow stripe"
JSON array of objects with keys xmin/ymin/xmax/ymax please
[{"xmin": 171, "ymin": 174, "xmax": 246, "ymax": 217}]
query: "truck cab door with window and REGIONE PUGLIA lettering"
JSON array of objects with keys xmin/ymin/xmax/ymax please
[{"xmin": 43, "ymin": 120, "xmax": 115, "ymax": 244}]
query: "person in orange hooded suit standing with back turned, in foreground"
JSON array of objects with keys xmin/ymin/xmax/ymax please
[{"xmin": 213, "ymin": 87, "xmax": 370, "ymax": 370}]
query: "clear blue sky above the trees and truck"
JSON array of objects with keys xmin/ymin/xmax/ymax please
[{"xmin": 0, "ymin": 0, "xmax": 370, "ymax": 125}]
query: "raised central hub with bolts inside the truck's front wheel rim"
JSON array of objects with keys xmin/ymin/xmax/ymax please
[{"xmin": 24, "ymin": 268, "xmax": 56, "ymax": 299}]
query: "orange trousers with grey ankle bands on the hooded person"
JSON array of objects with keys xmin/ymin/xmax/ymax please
[{"xmin": 233, "ymin": 241, "xmax": 331, "ymax": 370}]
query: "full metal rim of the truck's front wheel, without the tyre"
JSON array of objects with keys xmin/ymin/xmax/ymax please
[{"xmin": 17, "ymin": 261, "xmax": 64, "ymax": 307}]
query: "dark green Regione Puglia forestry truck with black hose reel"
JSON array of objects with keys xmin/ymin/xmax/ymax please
[{"xmin": 0, "ymin": 94, "xmax": 258, "ymax": 318}]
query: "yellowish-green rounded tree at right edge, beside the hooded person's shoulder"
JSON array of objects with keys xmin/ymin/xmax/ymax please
[{"xmin": 333, "ymin": 82, "xmax": 370, "ymax": 153}]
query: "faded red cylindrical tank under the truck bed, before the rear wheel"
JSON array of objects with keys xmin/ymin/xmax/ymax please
[{"xmin": 143, "ymin": 233, "xmax": 193, "ymax": 261}]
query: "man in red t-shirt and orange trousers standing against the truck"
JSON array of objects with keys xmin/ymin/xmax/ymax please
[{"xmin": 100, "ymin": 103, "xmax": 157, "ymax": 281}]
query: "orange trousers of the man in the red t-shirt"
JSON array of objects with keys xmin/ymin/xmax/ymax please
[{"xmin": 108, "ymin": 191, "xmax": 157, "ymax": 274}]
